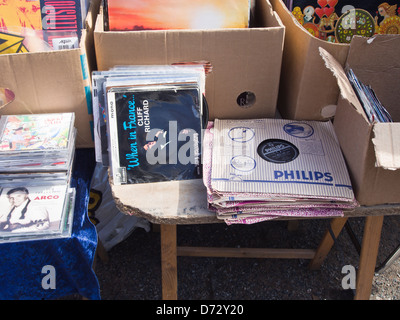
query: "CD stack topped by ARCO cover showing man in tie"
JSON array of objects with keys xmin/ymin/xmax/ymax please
[{"xmin": 0, "ymin": 185, "xmax": 75, "ymax": 243}]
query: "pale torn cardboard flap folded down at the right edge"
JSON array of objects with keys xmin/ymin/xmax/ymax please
[{"xmin": 372, "ymin": 123, "xmax": 400, "ymax": 170}]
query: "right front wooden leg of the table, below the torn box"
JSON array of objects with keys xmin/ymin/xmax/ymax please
[{"xmin": 355, "ymin": 216, "xmax": 383, "ymax": 300}]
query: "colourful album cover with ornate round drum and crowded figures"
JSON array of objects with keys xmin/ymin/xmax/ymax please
[{"xmin": 286, "ymin": 0, "xmax": 400, "ymax": 43}]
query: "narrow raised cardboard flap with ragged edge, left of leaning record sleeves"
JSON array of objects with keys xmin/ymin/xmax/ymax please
[{"xmin": 319, "ymin": 47, "xmax": 362, "ymax": 110}]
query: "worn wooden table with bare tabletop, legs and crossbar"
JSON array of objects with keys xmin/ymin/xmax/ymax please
[{"xmin": 111, "ymin": 180, "xmax": 400, "ymax": 300}]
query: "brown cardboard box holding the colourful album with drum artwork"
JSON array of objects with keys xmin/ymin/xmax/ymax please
[{"xmin": 271, "ymin": 0, "xmax": 349, "ymax": 120}]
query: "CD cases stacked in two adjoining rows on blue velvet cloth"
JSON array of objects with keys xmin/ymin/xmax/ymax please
[{"xmin": 0, "ymin": 113, "xmax": 76, "ymax": 243}]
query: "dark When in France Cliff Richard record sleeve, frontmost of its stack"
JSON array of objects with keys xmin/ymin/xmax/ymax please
[{"xmin": 107, "ymin": 85, "xmax": 202, "ymax": 185}]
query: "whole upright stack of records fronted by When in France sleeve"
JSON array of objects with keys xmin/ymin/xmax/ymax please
[{"xmin": 92, "ymin": 64, "xmax": 208, "ymax": 185}]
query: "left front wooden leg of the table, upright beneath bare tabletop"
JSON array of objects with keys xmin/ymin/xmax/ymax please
[{"xmin": 160, "ymin": 224, "xmax": 178, "ymax": 300}]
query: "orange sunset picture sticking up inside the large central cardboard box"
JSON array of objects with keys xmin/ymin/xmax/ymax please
[{"xmin": 108, "ymin": 0, "xmax": 250, "ymax": 31}]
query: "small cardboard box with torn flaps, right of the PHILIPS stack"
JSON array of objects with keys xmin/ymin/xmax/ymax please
[{"xmin": 321, "ymin": 35, "xmax": 400, "ymax": 205}]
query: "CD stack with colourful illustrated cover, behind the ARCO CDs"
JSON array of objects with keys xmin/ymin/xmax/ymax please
[{"xmin": 0, "ymin": 113, "xmax": 76, "ymax": 173}]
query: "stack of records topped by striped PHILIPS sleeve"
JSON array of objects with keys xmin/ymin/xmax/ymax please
[{"xmin": 203, "ymin": 119, "xmax": 358, "ymax": 224}]
